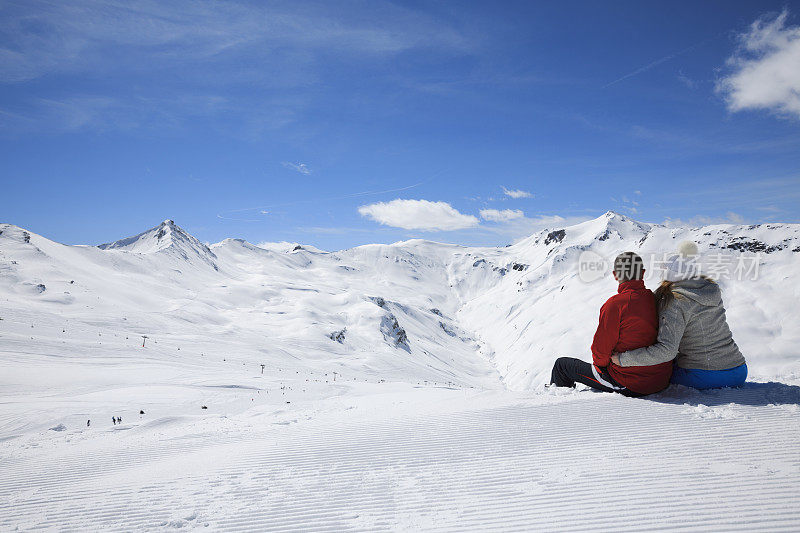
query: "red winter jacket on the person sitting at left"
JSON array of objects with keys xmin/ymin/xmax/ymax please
[{"xmin": 592, "ymin": 280, "xmax": 672, "ymax": 394}]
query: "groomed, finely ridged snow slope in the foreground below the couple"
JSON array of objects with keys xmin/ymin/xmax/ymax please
[{"xmin": 0, "ymin": 394, "xmax": 800, "ymax": 531}]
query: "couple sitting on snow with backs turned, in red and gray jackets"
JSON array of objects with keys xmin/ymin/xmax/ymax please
[{"xmin": 550, "ymin": 242, "xmax": 747, "ymax": 396}]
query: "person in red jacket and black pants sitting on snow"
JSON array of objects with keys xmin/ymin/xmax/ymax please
[{"xmin": 550, "ymin": 252, "xmax": 672, "ymax": 396}]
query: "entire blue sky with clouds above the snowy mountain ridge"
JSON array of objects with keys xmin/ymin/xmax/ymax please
[{"xmin": 0, "ymin": 0, "xmax": 800, "ymax": 249}]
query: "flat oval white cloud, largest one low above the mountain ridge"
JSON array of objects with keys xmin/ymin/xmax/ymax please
[{"xmin": 358, "ymin": 199, "xmax": 478, "ymax": 231}]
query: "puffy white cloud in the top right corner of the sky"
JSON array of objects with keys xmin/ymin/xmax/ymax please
[{"xmin": 717, "ymin": 10, "xmax": 800, "ymax": 117}]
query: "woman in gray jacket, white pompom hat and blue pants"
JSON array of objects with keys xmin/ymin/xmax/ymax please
[{"xmin": 612, "ymin": 241, "xmax": 747, "ymax": 389}]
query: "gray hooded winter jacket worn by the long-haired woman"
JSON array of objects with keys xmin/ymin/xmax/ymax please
[{"xmin": 619, "ymin": 278, "xmax": 745, "ymax": 370}]
